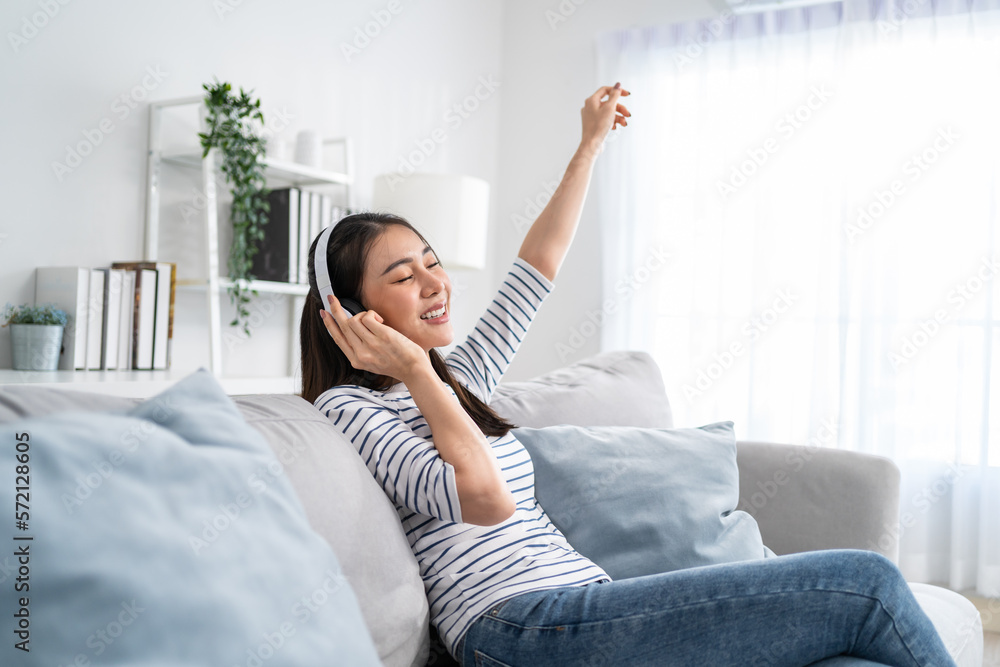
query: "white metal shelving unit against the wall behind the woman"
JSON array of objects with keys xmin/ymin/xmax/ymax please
[{"xmin": 144, "ymin": 97, "xmax": 354, "ymax": 383}]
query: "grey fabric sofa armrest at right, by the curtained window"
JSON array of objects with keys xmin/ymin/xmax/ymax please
[{"xmin": 736, "ymin": 442, "xmax": 899, "ymax": 562}]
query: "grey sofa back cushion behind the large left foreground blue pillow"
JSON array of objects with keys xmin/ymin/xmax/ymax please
[{"xmin": 0, "ymin": 378, "xmax": 430, "ymax": 667}]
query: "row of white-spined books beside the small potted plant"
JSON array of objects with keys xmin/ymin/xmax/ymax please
[{"xmin": 35, "ymin": 262, "xmax": 177, "ymax": 370}]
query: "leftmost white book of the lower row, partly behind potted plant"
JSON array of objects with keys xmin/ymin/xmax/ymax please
[{"xmin": 35, "ymin": 266, "xmax": 90, "ymax": 371}]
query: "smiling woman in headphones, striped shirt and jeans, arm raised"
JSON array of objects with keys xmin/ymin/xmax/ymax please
[{"xmin": 301, "ymin": 84, "xmax": 954, "ymax": 667}]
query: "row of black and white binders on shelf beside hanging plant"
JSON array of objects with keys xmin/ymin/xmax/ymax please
[{"xmin": 251, "ymin": 188, "xmax": 351, "ymax": 284}]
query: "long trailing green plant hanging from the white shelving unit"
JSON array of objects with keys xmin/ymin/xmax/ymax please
[{"xmin": 198, "ymin": 80, "xmax": 270, "ymax": 336}]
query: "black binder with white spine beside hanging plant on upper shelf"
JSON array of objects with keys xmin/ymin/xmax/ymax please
[{"xmin": 250, "ymin": 188, "xmax": 299, "ymax": 283}]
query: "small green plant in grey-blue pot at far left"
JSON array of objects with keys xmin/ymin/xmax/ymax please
[{"xmin": 0, "ymin": 303, "xmax": 66, "ymax": 371}]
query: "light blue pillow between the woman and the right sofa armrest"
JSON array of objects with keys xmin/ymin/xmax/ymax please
[{"xmin": 511, "ymin": 422, "xmax": 774, "ymax": 579}]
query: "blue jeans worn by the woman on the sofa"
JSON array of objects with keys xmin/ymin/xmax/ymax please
[{"xmin": 456, "ymin": 550, "xmax": 955, "ymax": 667}]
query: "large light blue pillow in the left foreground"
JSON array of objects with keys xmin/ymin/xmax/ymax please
[{"xmin": 0, "ymin": 370, "xmax": 380, "ymax": 667}]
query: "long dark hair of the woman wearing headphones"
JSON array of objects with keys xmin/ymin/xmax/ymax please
[{"xmin": 299, "ymin": 211, "xmax": 517, "ymax": 436}]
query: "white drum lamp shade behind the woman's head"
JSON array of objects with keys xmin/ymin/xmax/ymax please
[{"xmin": 372, "ymin": 173, "xmax": 490, "ymax": 269}]
